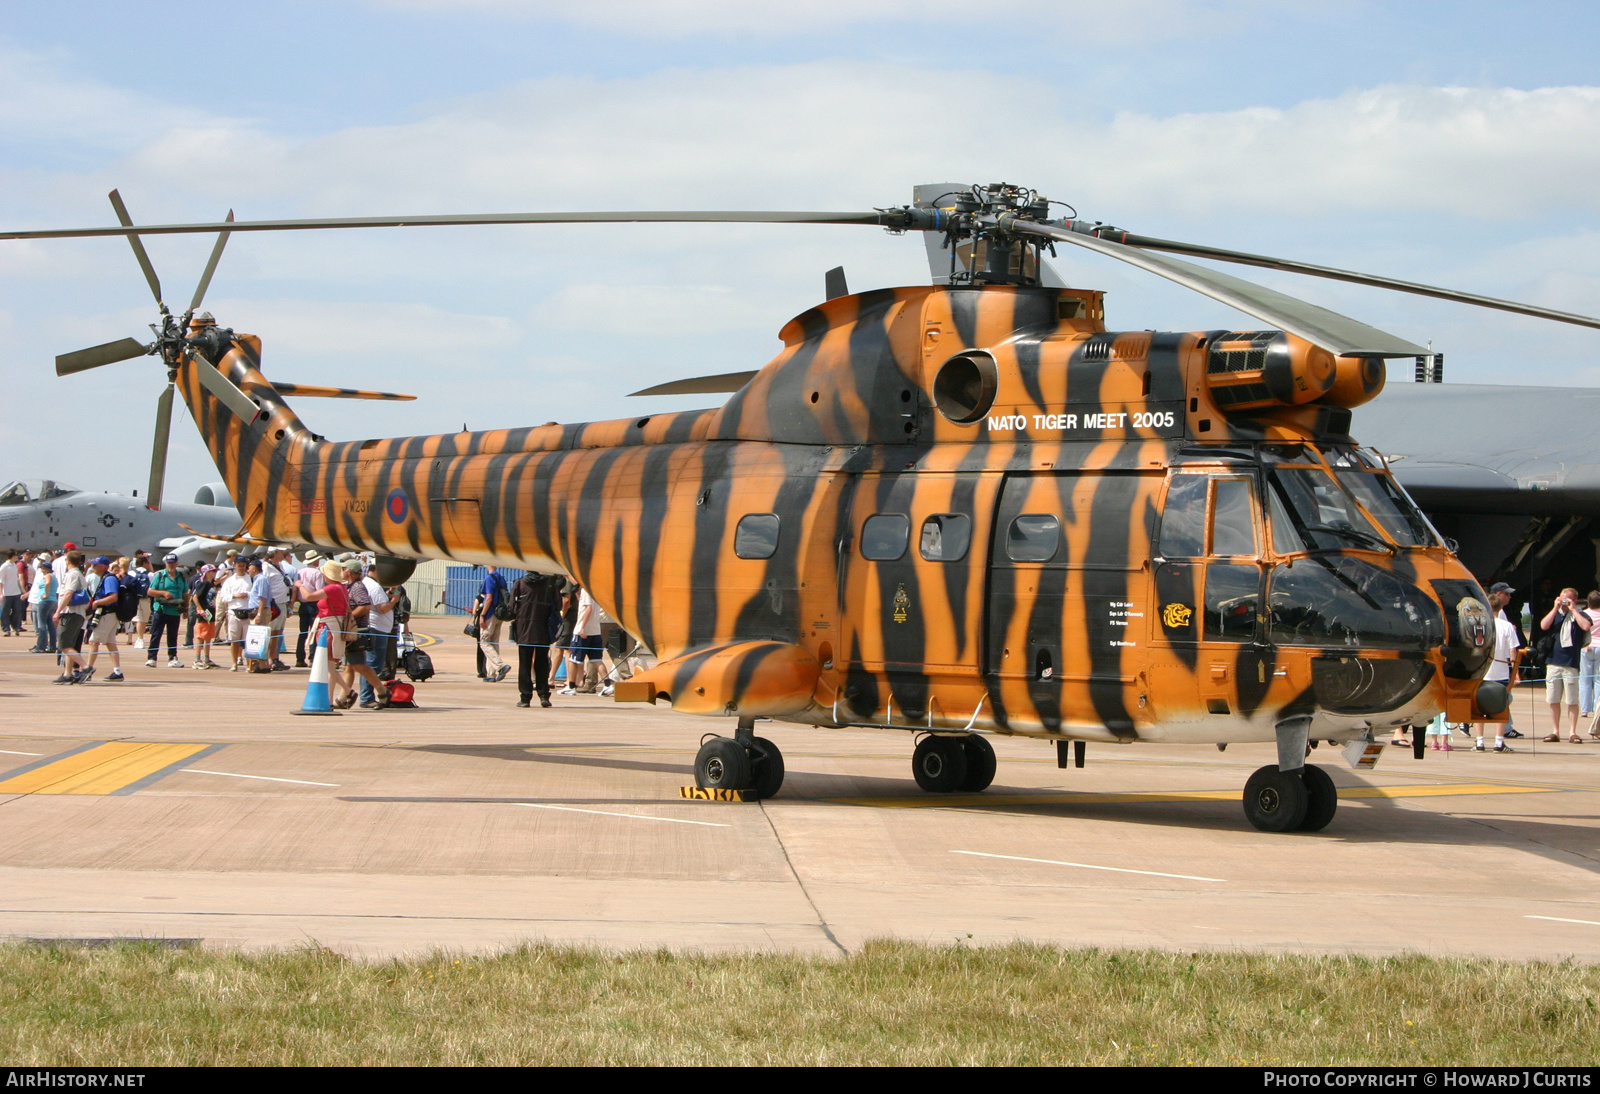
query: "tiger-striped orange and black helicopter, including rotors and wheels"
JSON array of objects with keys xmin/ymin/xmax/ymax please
[{"xmin": 15, "ymin": 184, "xmax": 1600, "ymax": 832}]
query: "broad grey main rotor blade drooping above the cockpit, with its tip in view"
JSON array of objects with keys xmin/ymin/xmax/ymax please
[{"xmin": 998, "ymin": 218, "xmax": 1427, "ymax": 357}]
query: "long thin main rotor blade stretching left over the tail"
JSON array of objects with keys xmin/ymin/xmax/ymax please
[{"xmin": 0, "ymin": 210, "xmax": 893, "ymax": 241}]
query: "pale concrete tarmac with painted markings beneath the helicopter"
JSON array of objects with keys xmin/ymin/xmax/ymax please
[{"xmin": 0, "ymin": 619, "xmax": 1600, "ymax": 961}]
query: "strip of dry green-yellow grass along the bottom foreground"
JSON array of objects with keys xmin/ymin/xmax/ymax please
[{"xmin": 0, "ymin": 942, "xmax": 1600, "ymax": 1067}]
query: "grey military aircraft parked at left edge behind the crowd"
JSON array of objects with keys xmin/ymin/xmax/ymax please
[{"xmin": 0, "ymin": 478, "xmax": 238, "ymax": 557}]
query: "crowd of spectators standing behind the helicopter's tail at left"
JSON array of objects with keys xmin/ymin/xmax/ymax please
[{"xmin": 0, "ymin": 542, "xmax": 638, "ymax": 709}]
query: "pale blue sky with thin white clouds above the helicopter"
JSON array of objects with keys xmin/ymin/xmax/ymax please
[{"xmin": 0, "ymin": 0, "xmax": 1600, "ymax": 499}]
